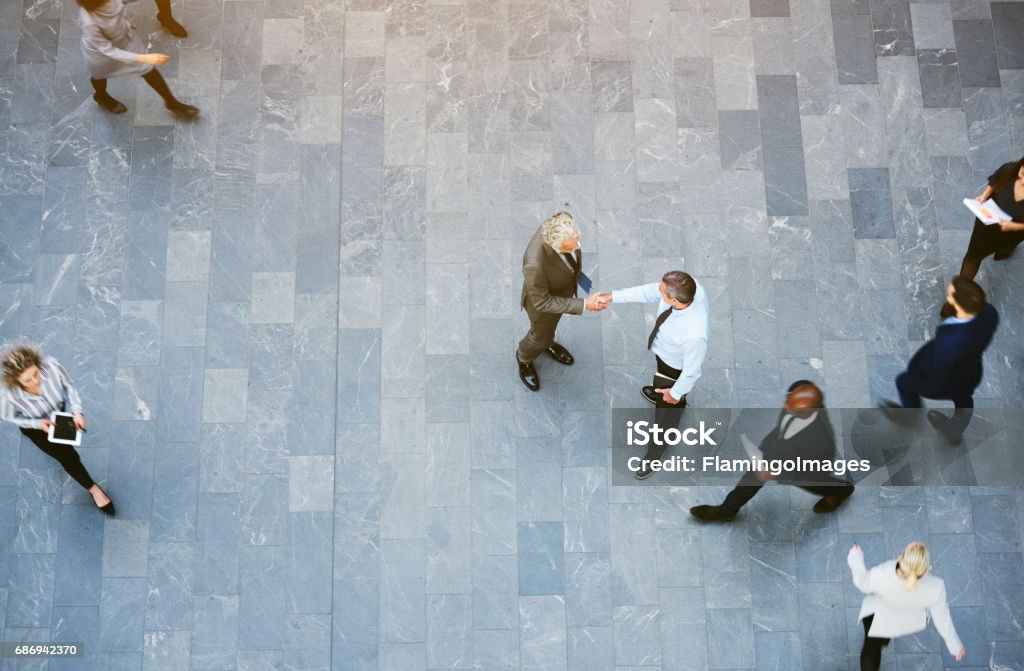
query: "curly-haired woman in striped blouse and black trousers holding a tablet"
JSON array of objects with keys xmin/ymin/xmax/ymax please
[{"xmin": 0, "ymin": 345, "xmax": 114, "ymax": 515}]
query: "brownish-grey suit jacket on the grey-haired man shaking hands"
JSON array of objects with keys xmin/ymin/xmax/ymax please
[{"xmin": 521, "ymin": 228, "xmax": 584, "ymax": 314}]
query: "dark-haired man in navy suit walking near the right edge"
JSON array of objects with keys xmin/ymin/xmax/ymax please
[{"xmin": 879, "ymin": 276, "xmax": 999, "ymax": 446}]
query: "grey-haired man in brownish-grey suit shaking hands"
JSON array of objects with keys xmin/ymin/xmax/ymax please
[{"xmin": 516, "ymin": 212, "xmax": 610, "ymax": 391}]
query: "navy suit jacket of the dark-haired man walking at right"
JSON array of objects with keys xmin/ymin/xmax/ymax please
[{"xmin": 907, "ymin": 304, "xmax": 999, "ymax": 399}]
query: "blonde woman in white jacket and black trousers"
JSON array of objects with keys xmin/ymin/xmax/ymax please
[{"xmin": 847, "ymin": 543, "xmax": 967, "ymax": 671}]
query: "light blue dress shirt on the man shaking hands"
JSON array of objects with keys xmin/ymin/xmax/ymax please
[{"xmin": 611, "ymin": 282, "xmax": 711, "ymax": 400}]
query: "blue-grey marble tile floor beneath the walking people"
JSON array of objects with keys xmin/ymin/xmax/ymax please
[{"xmin": 0, "ymin": 0, "xmax": 1024, "ymax": 671}]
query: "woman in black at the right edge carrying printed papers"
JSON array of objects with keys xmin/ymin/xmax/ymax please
[{"xmin": 959, "ymin": 159, "xmax": 1024, "ymax": 280}]
